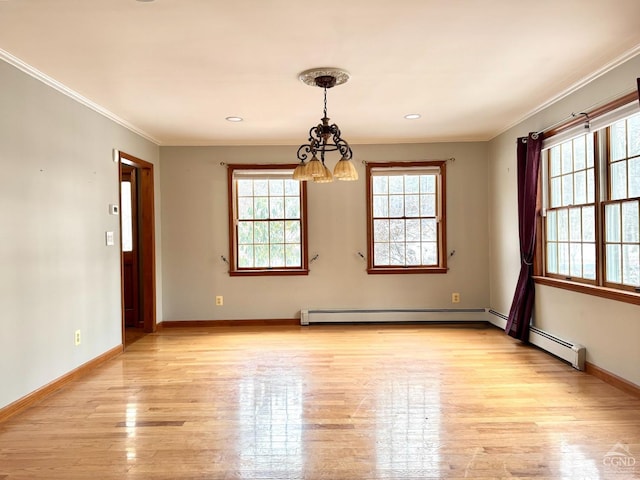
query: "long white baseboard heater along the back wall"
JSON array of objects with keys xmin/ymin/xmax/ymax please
[{"xmin": 300, "ymin": 308, "xmax": 487, "ymax": 325}]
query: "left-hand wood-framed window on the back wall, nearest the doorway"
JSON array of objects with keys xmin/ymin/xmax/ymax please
[{"xmin": 228, "ymin": 165, "xmax": 308, "ymax": 275}]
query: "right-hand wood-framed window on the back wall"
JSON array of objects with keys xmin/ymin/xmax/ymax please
[{"xmin": 367, "ymin": 161, "xmax": 447, "ymax": 273}]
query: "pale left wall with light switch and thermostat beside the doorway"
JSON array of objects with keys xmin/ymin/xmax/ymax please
[{"xmin": 0, "ymin": 61, "xmax": 162, "ymax": 408}]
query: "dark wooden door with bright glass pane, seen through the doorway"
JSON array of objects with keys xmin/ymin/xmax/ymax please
[{"xmin": 120, "ymin": 165, "xmax": 142, "ymax": 327}]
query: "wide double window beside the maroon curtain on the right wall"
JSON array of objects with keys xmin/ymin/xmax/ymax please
[{"xmin": 537, "ymin": 99, "xmax": 640, "ymax": 303}]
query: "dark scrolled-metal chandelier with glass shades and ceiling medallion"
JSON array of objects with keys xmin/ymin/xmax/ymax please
[{"xmin": 293, "ymin": 68, "xmax": 358, "ymax": 183}]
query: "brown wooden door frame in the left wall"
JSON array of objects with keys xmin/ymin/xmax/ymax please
[{"xmin": 118, "ymin": 152, "xmax": 156, "ymax": 336}]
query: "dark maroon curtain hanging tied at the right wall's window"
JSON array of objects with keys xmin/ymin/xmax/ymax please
[{"xmin": 505, "ymin": 133, "xmax": 542, "ymax": 343}]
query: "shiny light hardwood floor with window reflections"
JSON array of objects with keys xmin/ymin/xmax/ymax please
[{"xmin": 0, "ymin": 325, "xmax": 640, "ymax": 480}]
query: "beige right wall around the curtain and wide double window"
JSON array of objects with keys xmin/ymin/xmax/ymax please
[{"xmin": 488, "ymin": 56, "xmax": 640, "ymax": 385}]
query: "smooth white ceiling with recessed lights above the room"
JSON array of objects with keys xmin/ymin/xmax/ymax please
[{"xmin": 0, "ymin": 0, "xmax": 640, "ymax": 145}]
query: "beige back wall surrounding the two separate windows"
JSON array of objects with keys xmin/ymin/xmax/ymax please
[{"xmin": 160, "ymin": 143, "xmax": 489, "ymax": 320}]
